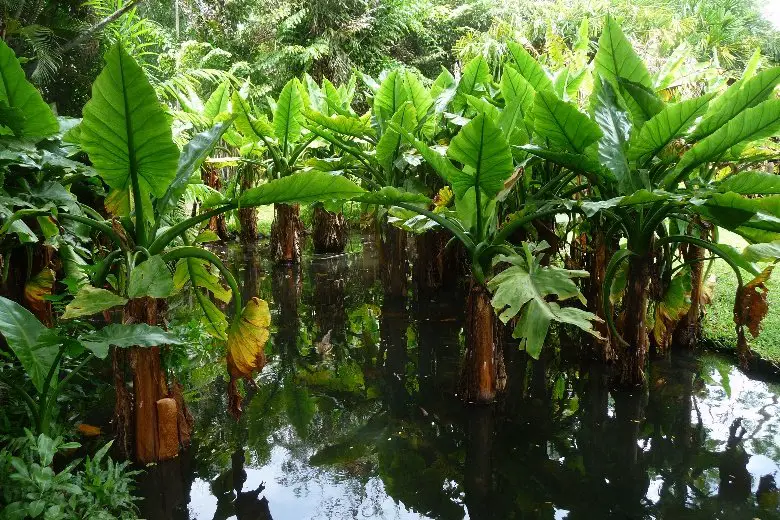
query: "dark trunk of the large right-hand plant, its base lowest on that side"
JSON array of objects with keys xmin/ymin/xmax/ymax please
[{"xmin": 618, "ymin": 255, "xmax": 652, "ymax": 385}]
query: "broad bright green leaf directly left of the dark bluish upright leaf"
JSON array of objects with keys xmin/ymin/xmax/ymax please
[{"xmin": 533, "ymin": 92, "xmax": 602, "ymax": 154}]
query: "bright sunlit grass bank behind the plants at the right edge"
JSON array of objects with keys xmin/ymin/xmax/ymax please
[{"xmin": 702, "ymin": 233, "xmax": 780, "ymax": 363}]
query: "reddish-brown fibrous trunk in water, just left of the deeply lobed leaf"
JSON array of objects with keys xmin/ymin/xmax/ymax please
[{"xmin": 460, "ymin": 282, "xmax": 506, "ymax": 403}]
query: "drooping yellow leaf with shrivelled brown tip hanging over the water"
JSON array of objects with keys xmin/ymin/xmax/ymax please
[{"xmin": 227, "ymin": 297, "xmax": 271, "ymax": 417}]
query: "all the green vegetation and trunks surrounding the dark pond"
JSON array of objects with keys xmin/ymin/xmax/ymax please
[{"xmin": 0, "ymin": 0, "xmax": 780, "ymax": 518}]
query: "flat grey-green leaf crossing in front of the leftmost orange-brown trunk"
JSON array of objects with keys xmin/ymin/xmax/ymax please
[{"xmin": 79, "ymin": 323, "xmax": 184, "ymax": 359}]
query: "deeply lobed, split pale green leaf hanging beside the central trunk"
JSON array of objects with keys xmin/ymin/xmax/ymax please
[{"xmin": 488, "ymin": 244, "xmax": 600, "ymax": 358}]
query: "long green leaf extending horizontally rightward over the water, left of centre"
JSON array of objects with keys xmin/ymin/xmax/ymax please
[{"xmin": 238, "ymin": 170, "xmax": 365, "ymax": 207}]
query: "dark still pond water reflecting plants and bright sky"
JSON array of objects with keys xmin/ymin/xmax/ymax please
[{"xmin": 137, "ymin": 237, "xmax": 780, "ymax": 520}]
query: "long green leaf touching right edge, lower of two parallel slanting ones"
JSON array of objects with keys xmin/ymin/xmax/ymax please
[{"xmin": 670, "ymin": 99, "xmax": 780, "ymax": 182}]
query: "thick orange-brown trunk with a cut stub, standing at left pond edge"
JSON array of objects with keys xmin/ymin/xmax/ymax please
[{"xmin": 113, "ymin": 298, "xmax": 192, "ymax": 463}]
